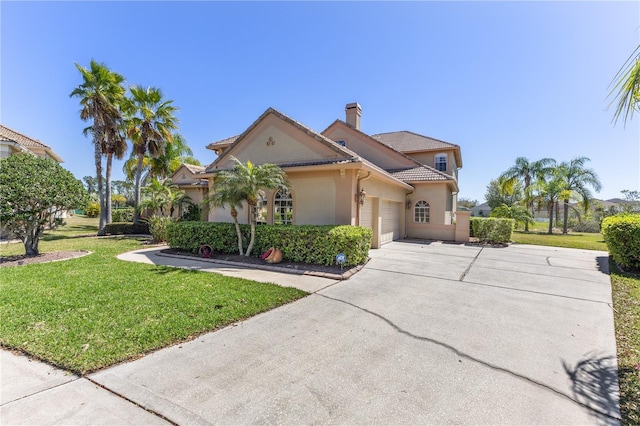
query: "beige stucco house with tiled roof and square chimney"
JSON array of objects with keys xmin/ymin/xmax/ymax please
[{"xmin": 172, "ymin": 103, "xmax": 469, "ymax": 248}]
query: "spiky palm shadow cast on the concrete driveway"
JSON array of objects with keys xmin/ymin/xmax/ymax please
[{"xmin": 562, "ymin": 354, "xmax": 620, "ymax": 424}]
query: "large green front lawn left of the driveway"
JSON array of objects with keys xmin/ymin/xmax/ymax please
[{"xmin": 0, "ymin": 216, "xmax": 306, "ymax": 374}]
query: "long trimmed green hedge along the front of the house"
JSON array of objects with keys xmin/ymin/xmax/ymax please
[{"xmin": 167, "ymin": 222, "xmax": 373, "ymax": 266}]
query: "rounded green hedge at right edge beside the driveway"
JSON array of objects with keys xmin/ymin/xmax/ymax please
[{"xmin": 602, "ymin": 213, "xmax": 640, "ymax": 271}]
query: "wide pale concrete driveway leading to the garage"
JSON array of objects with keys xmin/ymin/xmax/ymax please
[{"xmin": 3, "ymin": 242, "xmax": 619, "ymax": 424}]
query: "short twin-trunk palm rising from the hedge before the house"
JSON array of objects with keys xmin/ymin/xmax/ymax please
[{"xmin": 215, "ymin": 157, "xmax": 291, "ymax": 256}]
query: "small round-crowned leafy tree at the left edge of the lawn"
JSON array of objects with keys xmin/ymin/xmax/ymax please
[{"xmin": 0, "ymin": 153, "xmax": 89, "ymax": 256}]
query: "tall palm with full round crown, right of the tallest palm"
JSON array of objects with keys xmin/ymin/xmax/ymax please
[{"xmin": 128, "ymin": 86, "xmax": 178, "ymax": 222}]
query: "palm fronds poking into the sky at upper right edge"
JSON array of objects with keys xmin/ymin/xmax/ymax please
[{"xmin": 609, "ymin": 45, "xmax": 640, "ymax": 125}]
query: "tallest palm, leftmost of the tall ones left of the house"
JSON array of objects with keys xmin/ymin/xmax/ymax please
[{"xmin": 69, "ymin": 60, "xmax": 126, "ymax": 235}]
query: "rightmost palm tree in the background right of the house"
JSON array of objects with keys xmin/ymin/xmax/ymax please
[{"xmin": 558, "ymin": 157, "xmax": 602, "ymax": 234}]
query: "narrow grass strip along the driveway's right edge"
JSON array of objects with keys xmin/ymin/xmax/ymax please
[{"xmin": 610, "ymin": 261, "xmax": 640, "ymax": 425}]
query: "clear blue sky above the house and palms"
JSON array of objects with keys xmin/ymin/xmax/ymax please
[{"xmin": 0, "ymin": 0, "xmax": 640, "ymax": 201}]
